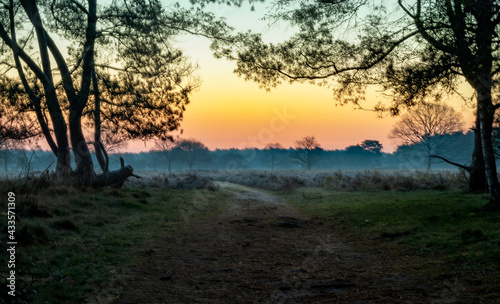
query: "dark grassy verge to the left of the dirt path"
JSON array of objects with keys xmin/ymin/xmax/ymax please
[{"xmin": 0, "ymin": 188, "xmax": 232, "ymax": 303}]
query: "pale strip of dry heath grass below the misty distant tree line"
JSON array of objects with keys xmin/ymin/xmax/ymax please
[{"xmin": 129, "ymin": 170, "xmax": 467, "ymax": 191}]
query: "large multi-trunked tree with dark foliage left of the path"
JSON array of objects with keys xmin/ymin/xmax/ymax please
[{"xmin": 0, "ymin": 0, "xmax": 229, "ymax": 187}]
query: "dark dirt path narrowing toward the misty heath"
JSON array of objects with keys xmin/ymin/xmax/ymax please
[{"xmin": 113, "ymin": 183, "xmax": 450, "ymax": 304}]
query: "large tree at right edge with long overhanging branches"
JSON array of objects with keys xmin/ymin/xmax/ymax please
[{"xmin": 202, "ymin": 0, "xmax": 500, "ymax": 208}]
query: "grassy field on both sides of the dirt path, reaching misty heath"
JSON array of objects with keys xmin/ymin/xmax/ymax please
[{"xmin": 1, "ymin": 171, "xmax": 500, "ymax": 303}]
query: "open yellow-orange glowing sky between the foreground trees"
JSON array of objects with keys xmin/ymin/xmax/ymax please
[{"xmin": 123, "ymin": 1, "xmax": 473, "ymax": 152}]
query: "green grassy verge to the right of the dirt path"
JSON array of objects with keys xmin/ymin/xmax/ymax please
[{"xmin": 280, "ymin": 188, "xmax": 500, "ymax": 283}]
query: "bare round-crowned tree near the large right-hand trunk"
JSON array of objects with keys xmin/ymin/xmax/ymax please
[{"xmin": 389, "ymin": 102, "xmax": 463, "ymax": 170}]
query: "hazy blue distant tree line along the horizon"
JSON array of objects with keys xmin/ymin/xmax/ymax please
[{"xmin": 0, "ymin": 131, "xmax": 474, "ymax": 175}]
